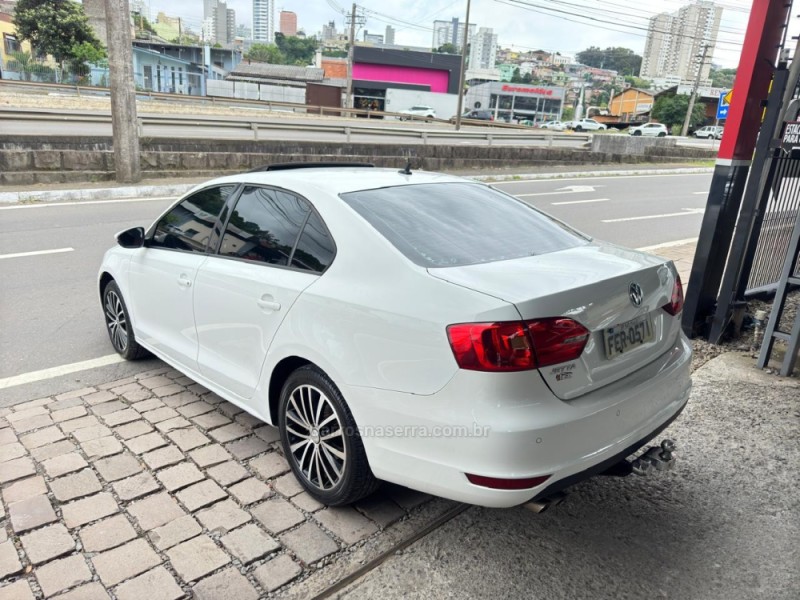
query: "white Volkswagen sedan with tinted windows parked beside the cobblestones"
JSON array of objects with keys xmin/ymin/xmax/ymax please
[{"xmin": 98, "ymin": 164, "xmax": 691, "ymax": 507}]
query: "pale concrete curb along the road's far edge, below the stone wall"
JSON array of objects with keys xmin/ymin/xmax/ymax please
[{"xmin": 0, "ymin": 167, "xmax": 713, "ymax": 204}]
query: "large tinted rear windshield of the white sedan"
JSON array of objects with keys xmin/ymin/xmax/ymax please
[{"xmin": 341, "ymin": 183, "xmax": 587, "ymax": 267}]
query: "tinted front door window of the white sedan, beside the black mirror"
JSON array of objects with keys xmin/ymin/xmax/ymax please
[{"xmin": 149, "ymin": 185, "xmax": 236, "ymax": 252}]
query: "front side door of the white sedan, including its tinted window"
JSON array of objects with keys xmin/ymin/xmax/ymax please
[{"xmin": 129, "ymin": 185, "xmax": 236, "ymax": 371}]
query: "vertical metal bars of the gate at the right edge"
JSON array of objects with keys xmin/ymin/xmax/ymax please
[{"xmin": 745, "ymin": 148, "xmax": 800, "ymax": 295}]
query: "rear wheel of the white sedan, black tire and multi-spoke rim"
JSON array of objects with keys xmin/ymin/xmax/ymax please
[{"xmin": 278, "ymin": 365, "xmax": 380, "ymax": 506}]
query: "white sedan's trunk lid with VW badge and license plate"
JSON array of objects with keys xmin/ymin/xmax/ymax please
[{"xmin": 428, "ymin": 244, "xmax": 676, "ymax": 400}]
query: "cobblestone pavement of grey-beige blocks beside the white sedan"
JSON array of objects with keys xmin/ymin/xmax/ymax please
[{"xmin": 0, "ymin": 367, "xmax": 440, "ymax": 600}]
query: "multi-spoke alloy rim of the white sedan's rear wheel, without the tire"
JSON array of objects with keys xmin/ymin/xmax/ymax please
[{"xmin": 284, "ymin": 385, "xmax": 347, "ymax": 490}]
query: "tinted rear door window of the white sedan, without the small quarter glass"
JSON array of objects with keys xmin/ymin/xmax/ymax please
[{"xmin": 219, "ymin": 187, "xmax": 311, "ymax": 266}]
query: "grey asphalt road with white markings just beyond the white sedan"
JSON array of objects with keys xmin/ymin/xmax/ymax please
[{"xmin": 0, "ymin": 175, "xmax": 711, "ymax": 403}]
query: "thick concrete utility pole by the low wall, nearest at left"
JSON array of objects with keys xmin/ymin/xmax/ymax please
[{"xmin": 105, "ymin": 0, "xmax": 142, "ymax": 183}]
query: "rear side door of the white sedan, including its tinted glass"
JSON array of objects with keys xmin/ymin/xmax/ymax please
[{"xmin": 194, "ymin": 186, "xmax": 333, "ymax": 399}]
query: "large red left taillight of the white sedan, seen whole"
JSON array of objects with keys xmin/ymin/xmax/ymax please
[{"xmin": 447, "ymin": 317, "xmax": 589, "ymax": 371}]
